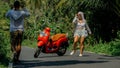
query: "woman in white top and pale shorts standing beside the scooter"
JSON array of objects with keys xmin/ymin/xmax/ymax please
[{"xmin": 70, "ymin": 12, "xmax": 91, "ymax": 56}]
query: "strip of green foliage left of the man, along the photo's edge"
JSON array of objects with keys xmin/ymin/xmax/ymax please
[{"xmin": 0, "ymin": 0, "xmax": 11, "ymax": 68}]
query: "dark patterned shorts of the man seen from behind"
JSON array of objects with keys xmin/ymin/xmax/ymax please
[{"xmin": 10, "ymin": 30, "xmax": 23, "ymax": 45}]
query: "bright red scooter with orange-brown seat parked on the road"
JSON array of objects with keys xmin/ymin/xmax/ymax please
[{"xmin": 34, "ymin": 27, "xmax": 69, "ymax": 58}]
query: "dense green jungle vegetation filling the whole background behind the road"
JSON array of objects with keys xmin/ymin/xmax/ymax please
[{"xmin": 0, "ymin": 0, "xmax": 120, "ymax": 65}]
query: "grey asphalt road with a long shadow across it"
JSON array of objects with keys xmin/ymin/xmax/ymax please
[{"xmin": 13, "ymin": 46, "xmax": 120, "ymax": 68}]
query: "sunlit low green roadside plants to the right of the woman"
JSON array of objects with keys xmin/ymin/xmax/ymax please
[{"xmin": 86, "ymin": 40, "xmax": 120, "ymax": 56}]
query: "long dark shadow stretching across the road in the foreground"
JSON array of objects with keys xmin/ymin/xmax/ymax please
[{"xmin": 13, "ymin": 60, "xmax": 108, "ymax": 68}]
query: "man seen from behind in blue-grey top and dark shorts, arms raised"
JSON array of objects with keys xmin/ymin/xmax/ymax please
[{"xmin": 6, "ymin": 1, "xmax": 30, "ymax": 62}]
